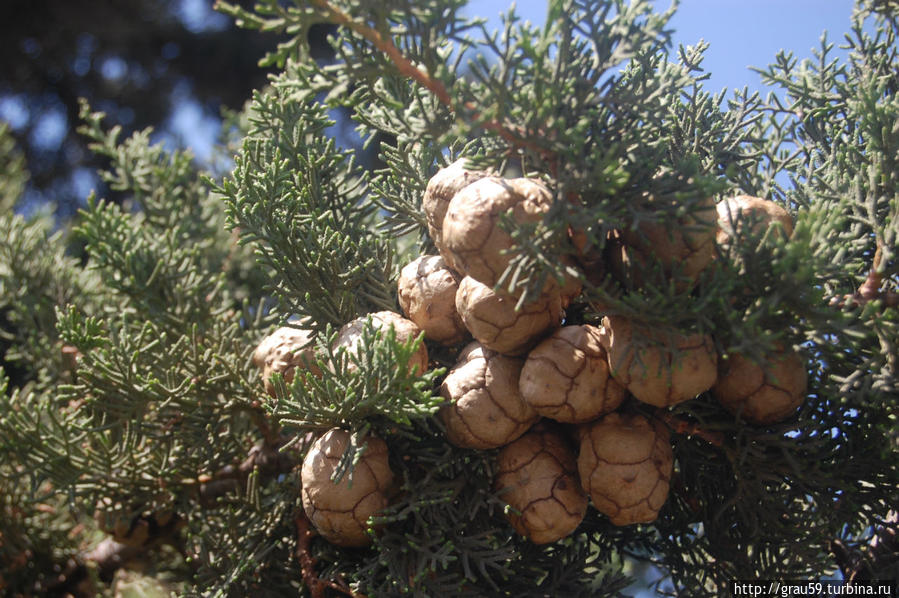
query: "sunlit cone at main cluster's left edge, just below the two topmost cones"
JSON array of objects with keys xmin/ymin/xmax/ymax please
[{"xmin": 397, "ymin": 255, "xmax": 468, "ymax": 345}]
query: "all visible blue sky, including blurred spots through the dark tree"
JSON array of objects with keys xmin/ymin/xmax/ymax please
[{"xmin": 0, "ymin": 0, "xmax": 854, "ymax": 194}]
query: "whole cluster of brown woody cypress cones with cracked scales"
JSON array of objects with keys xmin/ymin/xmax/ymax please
[{"xmin": 254, "ymin": 160, "xmax": 807, "ymax": 546}]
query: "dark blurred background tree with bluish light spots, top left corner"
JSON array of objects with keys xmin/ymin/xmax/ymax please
[{"xmin": 0, "ymin": 0, "xmax": 342, "ymax": 219}]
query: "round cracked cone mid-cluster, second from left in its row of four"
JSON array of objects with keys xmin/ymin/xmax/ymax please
[{"xmin": 519, "ymin": 324, "xmax": 627, "ymax": 423}]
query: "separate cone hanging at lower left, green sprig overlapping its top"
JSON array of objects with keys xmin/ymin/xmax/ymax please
[{"xmin": 300, "ymin": 428, "xmax": 393, "ymax": 546}]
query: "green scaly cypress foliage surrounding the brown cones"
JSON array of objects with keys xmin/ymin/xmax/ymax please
[{"xmin": 0, "ymin": 0, "xmax": 899, "ymax": 597}]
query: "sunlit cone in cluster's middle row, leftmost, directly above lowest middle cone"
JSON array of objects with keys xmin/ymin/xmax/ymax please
[{"xmin": 439, "ymin": 342, "xmax": 539, "ymax": 449}]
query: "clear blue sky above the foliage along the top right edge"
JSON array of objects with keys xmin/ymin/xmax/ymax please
[{"xmin": 466, "ymin": 0, "xmax": 854, "ymax": 91}]
